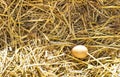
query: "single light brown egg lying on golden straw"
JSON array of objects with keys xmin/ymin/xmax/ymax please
[{"xmin": 71, "ymin": 45, "xmax": 88, "ymax": 59}]
